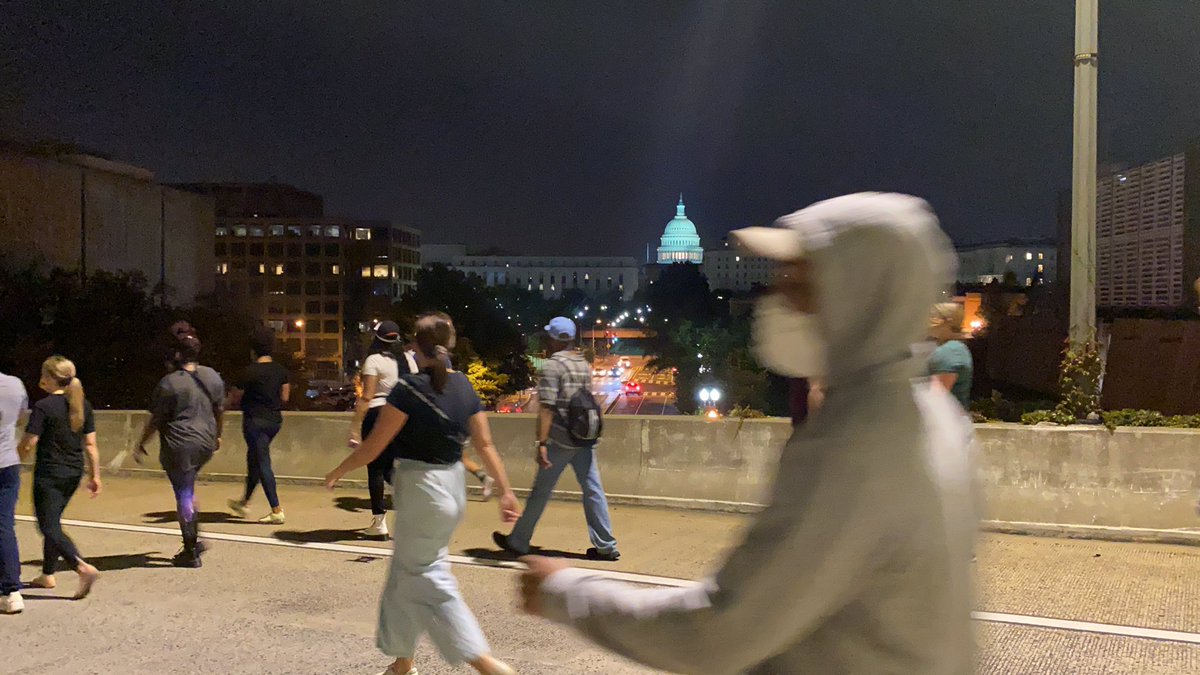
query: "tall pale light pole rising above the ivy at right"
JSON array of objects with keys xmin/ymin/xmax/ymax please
[{"xmin": 1070, "ymin": 0, "xmax": 1099, "ymax": 346}]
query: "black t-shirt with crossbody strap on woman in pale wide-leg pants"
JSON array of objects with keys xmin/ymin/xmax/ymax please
[{"xmin": 388, "ymin": 372, "xmax": 484, "ymax": 464}]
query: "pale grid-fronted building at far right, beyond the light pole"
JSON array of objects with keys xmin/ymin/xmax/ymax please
[{"xmin": 1096, "ymin": 145, "xmax": 1200, "ymax": 307}]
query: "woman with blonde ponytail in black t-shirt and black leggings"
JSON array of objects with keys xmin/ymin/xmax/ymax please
[{"xmin": 20, "ymin": 357, "xmax": 101, "ymax": 599}]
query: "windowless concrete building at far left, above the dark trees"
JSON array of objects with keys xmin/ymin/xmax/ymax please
[{"xmin": 0, "ymin": 143, "xmax": 214, "ymax": 305}]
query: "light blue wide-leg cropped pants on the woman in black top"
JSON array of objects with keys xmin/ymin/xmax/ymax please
[{"xmin": 376, "ymin": 459, "xmax": 491, "ymax": 664}]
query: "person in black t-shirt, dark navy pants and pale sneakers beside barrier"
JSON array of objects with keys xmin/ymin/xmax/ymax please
[{"xmin": 227, "ymin": 327, "xmax": 292, "ymax": 525}]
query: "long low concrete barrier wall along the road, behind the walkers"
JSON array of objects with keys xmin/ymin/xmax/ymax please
[{"xmin": 56, "ymin": 411, "xmax": 1200, "ymax": 528}]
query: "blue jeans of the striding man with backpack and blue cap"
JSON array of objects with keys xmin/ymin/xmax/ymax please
[{"xmin": 509, "ymin": 442, "xmax": 617, "ymax": 554}]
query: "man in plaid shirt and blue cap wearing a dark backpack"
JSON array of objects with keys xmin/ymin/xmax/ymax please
[{"xmin": 492, "ymin": 316, "xmax": 620, "ymax": 561}]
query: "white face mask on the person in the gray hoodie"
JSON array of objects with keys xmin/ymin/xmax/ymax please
[{"xmin": 752, "ymin": 293, "xmax": 828, "ymax": 377}]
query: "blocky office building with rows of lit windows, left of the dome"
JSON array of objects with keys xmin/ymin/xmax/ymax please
[{"xmin": 176, "ymin": 184, "xmax": 420, "ymax": 380}]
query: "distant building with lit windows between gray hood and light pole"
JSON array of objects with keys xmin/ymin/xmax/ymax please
[{"xmin": 955, "ymin": 239, "xmax": 1058, "ymax": 286}]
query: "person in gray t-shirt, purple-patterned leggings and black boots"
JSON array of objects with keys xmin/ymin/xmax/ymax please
[{"xmin": 134, "ymin": 322, "xmax": 224, "ymax": 567}]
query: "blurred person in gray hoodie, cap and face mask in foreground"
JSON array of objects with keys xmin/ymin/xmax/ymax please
[{"xmin": 521, "ymin": 193, "xmax": 977, "ymax": 675}]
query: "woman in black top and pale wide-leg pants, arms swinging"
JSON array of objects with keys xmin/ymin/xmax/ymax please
[{"xmin": 325, "ymin": 313, "xmax": 520, "ymax": 675}]
